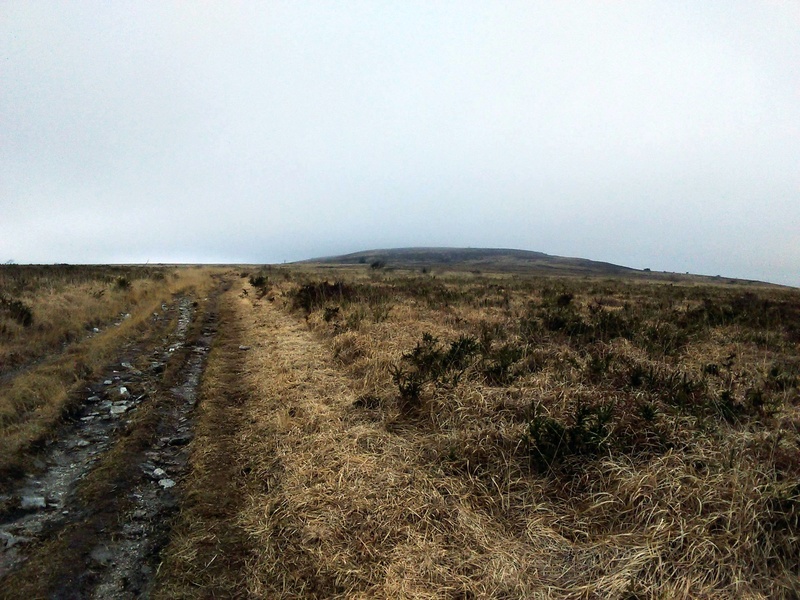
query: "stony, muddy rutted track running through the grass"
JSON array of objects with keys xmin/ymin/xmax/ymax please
[{"xmin": 0, "ymin": 280, "xmax": 229, "ymax": 599}]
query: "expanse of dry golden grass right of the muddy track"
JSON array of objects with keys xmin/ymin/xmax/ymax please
[{"xmin": 200, "ymin": 269, "xmax": 800, "ymax": 598}]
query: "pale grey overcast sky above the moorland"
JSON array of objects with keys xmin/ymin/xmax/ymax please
[{"xmin": 0, "ymin": 0, "xmax": 800, "ymax": 285}]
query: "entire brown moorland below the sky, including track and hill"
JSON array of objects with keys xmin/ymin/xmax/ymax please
[{"xmin": 0, "ymin": 249, "xmax": 800, "ymax": 599}]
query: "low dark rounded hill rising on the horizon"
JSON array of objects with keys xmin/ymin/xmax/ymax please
[{"xmin": 302, "ymin": 248, "xmax": 642, "ymax": 275}]
